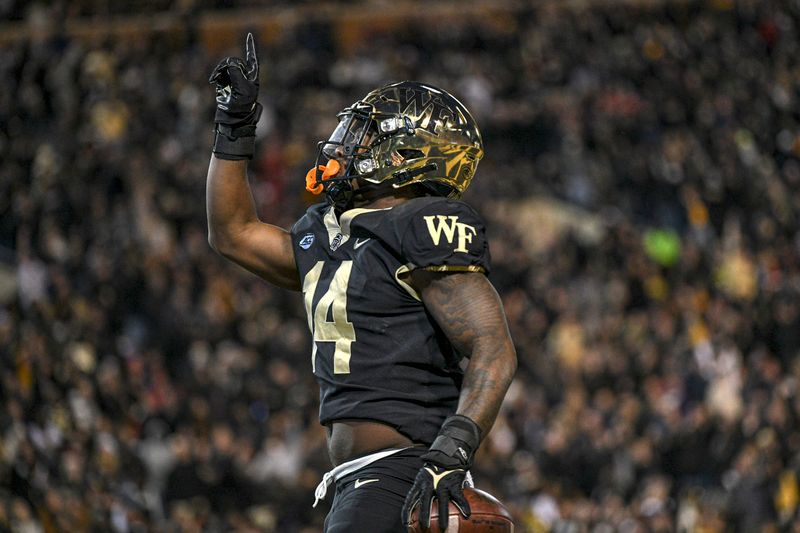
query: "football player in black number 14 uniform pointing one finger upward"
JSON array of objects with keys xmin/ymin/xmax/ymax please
[{"xmin": 207, "ymin": 34, "xmax": 516, "ymax": 533}]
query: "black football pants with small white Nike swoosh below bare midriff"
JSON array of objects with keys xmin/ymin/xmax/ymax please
[{"xmin": 325, "ymin": 448, "xmax": 427, "ymax": 533}]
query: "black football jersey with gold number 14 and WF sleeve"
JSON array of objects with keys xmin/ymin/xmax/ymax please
[{"xmin": 292, "ymin": 197, "xmax": 490, "ymax": 444}]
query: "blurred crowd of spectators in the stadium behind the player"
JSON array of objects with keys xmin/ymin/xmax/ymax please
[{"xmin": 0, "ymin": 0, "xmax": 800, "ymax": 533}]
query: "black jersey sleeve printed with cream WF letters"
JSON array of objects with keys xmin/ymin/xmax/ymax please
[{"xmin": 401, "ymin": 200, "xmax": 491, "ymax": 274}]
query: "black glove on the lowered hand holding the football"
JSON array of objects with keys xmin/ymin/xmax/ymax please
[{"xmin": 402, "ymin": 415, "xmax": 481, "ymax": 531}]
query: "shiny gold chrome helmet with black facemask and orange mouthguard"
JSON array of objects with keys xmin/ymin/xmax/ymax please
[{"xmin": 306, "ymin": 81, "xmax": 483, "ymax": 206}]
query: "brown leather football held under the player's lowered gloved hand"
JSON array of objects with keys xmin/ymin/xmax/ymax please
[{"xmin": 408, "ymin": 488, "xmax": 514, "ymax": 533}]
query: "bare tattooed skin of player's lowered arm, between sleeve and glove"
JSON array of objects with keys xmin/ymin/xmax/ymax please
[{"xmin": 411, "ymin": 270, "xmax": 517, "ymax": 436}]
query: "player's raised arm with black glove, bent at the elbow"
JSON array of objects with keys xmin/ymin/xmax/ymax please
[{"xmin": 206, "ymin": 34, "xmax": 300, "ymax": 290}]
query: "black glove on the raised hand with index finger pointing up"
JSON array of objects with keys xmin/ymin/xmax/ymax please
[{"xmin": 208, "ymin": 33, "xmax": 262, "ymax": 160}]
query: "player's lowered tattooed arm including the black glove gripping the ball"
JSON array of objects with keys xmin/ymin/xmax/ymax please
[{"xmin": 404, "ymin": 270, "xmax": 517, "ymax": 529}]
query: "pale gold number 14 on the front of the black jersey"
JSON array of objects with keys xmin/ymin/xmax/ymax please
[{"xmin": 303, "ymin": 261, "xmax": 356, "ymax": 374}]
